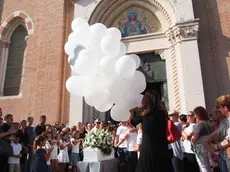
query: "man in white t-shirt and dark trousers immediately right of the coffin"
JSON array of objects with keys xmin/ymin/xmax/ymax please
[{"xmin": 115, "ymin": 121, "xmax": 128, "ymax": 172}]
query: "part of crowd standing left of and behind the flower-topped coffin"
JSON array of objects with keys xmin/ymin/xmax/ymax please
[{"xmin": 0, "ymin": 114, "xmax": 123, "ymax": 172}]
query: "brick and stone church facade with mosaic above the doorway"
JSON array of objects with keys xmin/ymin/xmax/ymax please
[{"xmin": 0, "ymin": 0, "xmax": 230, "ymax": 124}]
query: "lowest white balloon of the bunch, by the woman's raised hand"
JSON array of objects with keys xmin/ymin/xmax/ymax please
[{"xmin": 111, "ymin": 105, "xmax": 130, "ymax": 121}]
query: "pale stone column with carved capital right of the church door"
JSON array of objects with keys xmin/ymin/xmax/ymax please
[{"xmin": 166, "ymin": 20, "xmax": 205, "ymax": 113}]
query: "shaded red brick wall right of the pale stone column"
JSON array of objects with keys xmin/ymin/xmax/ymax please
[{"xmin": 193, "ymin": 0, "xmax": 230, "ymax": 110}]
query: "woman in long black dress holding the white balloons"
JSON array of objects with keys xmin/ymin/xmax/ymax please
[{"xmin": 131, "ymin": 91, "xmax": 173, "ymax": 172}]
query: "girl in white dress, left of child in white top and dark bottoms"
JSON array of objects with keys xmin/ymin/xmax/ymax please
[{"xmin": 58, "ymin": 132, "xmax": 71, "ymax": 172}]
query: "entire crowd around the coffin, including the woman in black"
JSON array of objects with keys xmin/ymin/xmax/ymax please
[{"xmin": 0, "ymin": 91, "xmax": 230, "ymax": 172}]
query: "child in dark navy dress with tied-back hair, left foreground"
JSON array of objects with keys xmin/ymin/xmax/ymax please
[{"xmin": 34, "ymin": 135, "xmax": 54, "ymax": 172}]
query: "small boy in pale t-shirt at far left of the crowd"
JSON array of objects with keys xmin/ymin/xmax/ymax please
[{"xmin": 8, "ymin": 135, "xmax": 22, "ymax": 172}]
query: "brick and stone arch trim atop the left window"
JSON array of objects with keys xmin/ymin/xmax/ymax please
[{"xmin": 0, "ymin": 11, "xmax": 34, "ymax": 39}]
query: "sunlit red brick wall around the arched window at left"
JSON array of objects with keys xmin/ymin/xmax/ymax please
[{"xmin": 0, "ymin": 0, "xmax": 71, "ymax": 122}]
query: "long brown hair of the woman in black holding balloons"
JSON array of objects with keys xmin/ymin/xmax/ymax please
[{"xmin": 142, "ymin": 90, "xmax": 163, "ymax": 115}]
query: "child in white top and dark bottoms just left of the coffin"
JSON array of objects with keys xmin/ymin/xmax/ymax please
[{"xmin": 70, "ymin": 131, "xmax": 81, "ymax": 172}]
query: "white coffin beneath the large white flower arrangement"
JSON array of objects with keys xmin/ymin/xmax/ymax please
[{"xmin": 83, "ymin": 147, "xmax": 114, "ymax": 162}]
